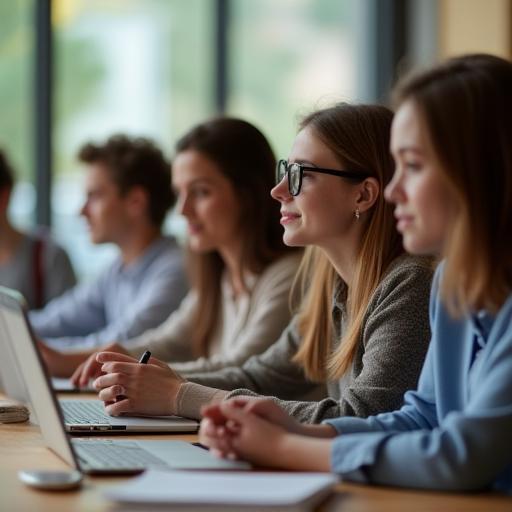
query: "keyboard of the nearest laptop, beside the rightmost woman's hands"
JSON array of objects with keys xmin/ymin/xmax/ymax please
[{"xmin": 73, "ymin": 441, "xmax": 168, "ymax": 469}]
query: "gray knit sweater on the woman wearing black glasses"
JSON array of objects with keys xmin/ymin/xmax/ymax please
[{"xmin": 175, "ymin": 255, "xmax": 433, "ymax": 423}]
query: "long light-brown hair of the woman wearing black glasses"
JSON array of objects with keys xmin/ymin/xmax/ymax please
[{"xmin": 294, "ymin": 103, "xmax": 404, "ymax": 381}]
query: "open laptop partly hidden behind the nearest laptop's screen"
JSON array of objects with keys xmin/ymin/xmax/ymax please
[{"xmin": 0, "ymin": 287, "xmax": 199, "ymax": 434}]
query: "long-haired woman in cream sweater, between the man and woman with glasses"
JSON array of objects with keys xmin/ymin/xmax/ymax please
[{"xmin": 43, "ymin": 118, "xmax": 301, "ymax": 386}]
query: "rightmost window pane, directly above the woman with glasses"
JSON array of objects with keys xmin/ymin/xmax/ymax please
[{"xmin": 228, "ymin": 0, "xmax": 356, "ymax": 157}]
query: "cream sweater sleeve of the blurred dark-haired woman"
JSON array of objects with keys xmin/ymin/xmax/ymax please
[{"xmin": 172, "ymin": 254, "xmax": 300, "ymax": 377}]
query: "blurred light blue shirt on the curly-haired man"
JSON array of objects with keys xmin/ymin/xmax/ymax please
[{"xmin": 30, "ymin": 237, "xmax": 188, "ymax": 348}]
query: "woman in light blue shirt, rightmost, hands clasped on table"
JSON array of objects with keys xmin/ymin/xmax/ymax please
[{"xmin": 201, "ymin": 55, "xmax": 512, "ymax": 492}]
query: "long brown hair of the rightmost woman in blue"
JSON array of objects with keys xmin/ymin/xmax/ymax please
[{"xmin": 395, "ymin": 54, "xmax": 512, "ymax": 315}]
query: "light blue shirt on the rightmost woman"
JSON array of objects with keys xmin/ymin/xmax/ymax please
[{"xmin": 326, "ymin": 269, "xmax": 512, "ymax": 492}]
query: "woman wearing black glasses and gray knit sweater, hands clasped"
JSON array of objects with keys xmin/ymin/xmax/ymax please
[{"xmin": 91, "ymin": 104, "xmax": 432, "ymax": 422}]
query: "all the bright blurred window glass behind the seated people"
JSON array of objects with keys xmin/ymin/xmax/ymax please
[{"xmin": 0, "ymin": 0, "xmax": 363, "ymax": 277}]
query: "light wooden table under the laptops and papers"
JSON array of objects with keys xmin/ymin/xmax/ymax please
[{"xmin": 0, "ymin": 395, "xmax": 512, "ymax": 512}]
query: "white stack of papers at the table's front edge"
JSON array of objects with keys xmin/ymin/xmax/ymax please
[{"xmin": 105, "ymin": 470, "xmax": 338, "ymax": 511}]
